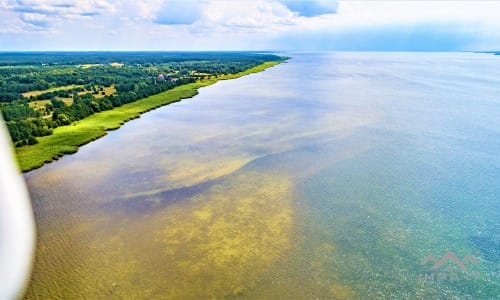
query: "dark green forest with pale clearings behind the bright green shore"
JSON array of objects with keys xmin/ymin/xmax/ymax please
[{"xmin": 0, "ymin": 52, "xmax": 283, "ymax": 147}]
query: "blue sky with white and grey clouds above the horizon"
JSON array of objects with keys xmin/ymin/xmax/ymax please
[{"xmin": 0, "ymin": 0, "xmax": 500, "ymax": 51}]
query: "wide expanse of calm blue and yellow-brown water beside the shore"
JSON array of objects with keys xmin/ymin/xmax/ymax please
[{"xmin": 26, "ymin": 52, "xmax": 500, "ymax": 299}]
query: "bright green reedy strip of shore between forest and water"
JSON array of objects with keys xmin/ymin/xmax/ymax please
[{"xmin": 16, "ymin": 61, "xmax": 280, "ymax": 172}]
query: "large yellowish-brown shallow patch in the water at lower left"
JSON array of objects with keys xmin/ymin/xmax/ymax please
[{"xmin": 26, "ymin": 172, "xmax": 294, "ymax": 299}]
